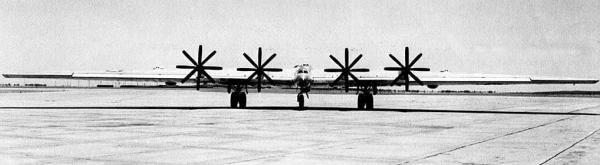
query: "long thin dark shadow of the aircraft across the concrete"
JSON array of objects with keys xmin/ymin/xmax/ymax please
[{"xmin": 0, "ymin": 106, "xmax": 600, "ymax": 116}]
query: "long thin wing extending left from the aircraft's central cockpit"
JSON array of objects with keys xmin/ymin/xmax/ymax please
[{"xmin": 2, "ymin": 71, "xmax": 292, "ymax": 85}]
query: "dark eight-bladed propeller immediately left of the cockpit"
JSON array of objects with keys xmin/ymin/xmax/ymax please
[{"xmin": 237, "ymin": 47, "xmax": 283, "ymax": 92}]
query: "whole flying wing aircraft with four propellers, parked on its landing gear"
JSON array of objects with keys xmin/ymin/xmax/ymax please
[{"xmin": 3, "ymin": 45, "xmax": 598, "ymax": 109}]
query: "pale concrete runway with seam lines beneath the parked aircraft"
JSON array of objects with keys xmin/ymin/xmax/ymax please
[{"xmin": 0, "ymin": 89, "xmax": 600, "ymax": 164}]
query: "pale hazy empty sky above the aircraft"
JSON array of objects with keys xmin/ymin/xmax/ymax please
[{"xmin": 0, "ymin": 0, "xmax": 600, "ymax": 89}]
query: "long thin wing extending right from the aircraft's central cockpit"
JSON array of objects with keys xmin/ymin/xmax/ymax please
[{"xmin": 313, "ymin": 72, "xmax": 598, "ymax": 86}]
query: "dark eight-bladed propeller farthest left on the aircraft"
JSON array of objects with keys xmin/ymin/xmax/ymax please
[{"xmin": 176, "ymin": 45, "xmax": 223, "ymax": 90}]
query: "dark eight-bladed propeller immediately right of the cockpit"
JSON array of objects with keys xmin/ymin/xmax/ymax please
[{"xmin": 325, "ymin": 48, "xmax": 369, "ymax": 92}]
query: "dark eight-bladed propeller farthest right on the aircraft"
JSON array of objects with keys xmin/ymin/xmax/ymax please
[{"xmin": 383, "ymin": 47, "xmax": 429, "ymax": 91}]
